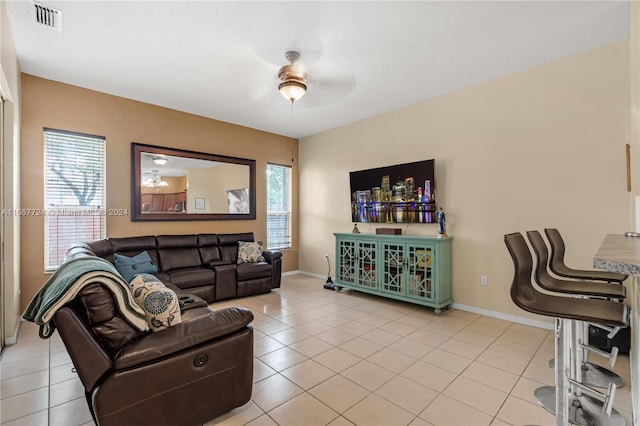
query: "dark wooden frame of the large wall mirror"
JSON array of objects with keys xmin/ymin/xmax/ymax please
[{"xmin": 131, "ymin": 142, "xmax": 256, "ymax": 222}]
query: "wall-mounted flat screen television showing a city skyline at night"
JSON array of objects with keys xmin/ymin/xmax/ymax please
[{"xmin": 349, "ymin": 159, "xmax": 436, "ymax": 223}]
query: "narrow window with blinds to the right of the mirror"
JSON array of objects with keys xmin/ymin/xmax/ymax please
[{"xmin": 267, "ymin": 164, "xmax": 291, "ymax": 250}]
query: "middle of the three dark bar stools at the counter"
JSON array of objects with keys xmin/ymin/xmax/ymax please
[{"xmin": 527, "ymin": 231, "xmax": 626, "ymax": 388}]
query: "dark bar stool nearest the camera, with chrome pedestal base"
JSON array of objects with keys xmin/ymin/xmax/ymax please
[{"xmin": 504, "ymin": 233, "xmax": 629, "ymax": 425}]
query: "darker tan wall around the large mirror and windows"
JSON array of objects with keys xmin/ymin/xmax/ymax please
[{"xmin": 21, "ymin": 74, "xmax": 298, "ymax": 307}]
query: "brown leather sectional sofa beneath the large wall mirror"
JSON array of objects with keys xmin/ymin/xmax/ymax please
[{"xmin": 70, "ymin": 232, "xmax": 282, "ymax": 303}]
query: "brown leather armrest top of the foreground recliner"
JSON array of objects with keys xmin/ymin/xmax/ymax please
[{"xmin": 114, "ymin": 308, "xmax": 253, "ymax": 370}]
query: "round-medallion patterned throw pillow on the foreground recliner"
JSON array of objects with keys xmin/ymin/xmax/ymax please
[{"xmin": 131, "ymin": 274, "xmax": 182, "ymax": 331}]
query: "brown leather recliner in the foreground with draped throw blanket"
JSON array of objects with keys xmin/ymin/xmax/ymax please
[{"xmin": 54, "ymin": 283, "xmax": 253, "ymax": 426}]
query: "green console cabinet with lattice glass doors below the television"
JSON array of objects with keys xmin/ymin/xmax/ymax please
[{"xmin": 334, "ymin": 233, "xmax": 453, "ymax": 315}]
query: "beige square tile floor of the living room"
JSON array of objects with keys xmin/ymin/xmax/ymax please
[{"xmin": 0, "ymin": 275, "xmax": 631, "ymax": 426}]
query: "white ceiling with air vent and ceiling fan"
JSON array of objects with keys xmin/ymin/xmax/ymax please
[{"xmin": 6, "ymin": 0, "xmax": 630, "ymax": 138}]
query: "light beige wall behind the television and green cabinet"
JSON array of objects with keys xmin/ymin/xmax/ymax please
[{"xmin": 300, "ymin": 41, "xmax": 639, "ymax": 320}]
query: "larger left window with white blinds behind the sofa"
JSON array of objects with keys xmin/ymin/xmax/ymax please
[{"xmin": 44, "ymin": 128, "xmax": 105, "ymax": 271}]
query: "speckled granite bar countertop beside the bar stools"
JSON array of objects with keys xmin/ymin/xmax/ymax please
[{"xmin": 593, "ymin": 234, "xmax": 640, "ymax": 275}]
